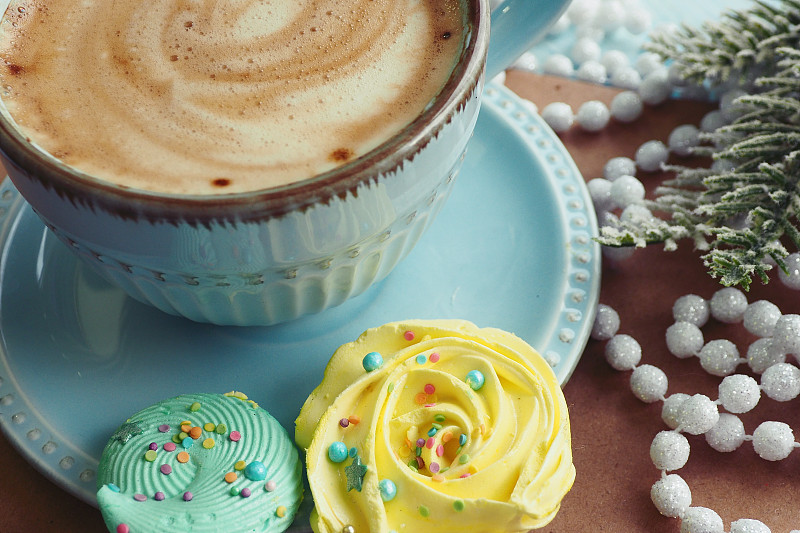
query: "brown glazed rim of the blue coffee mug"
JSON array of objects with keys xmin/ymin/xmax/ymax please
[{"xmin": 0, "ymin": 0, "xmax": 489, "ymax": 225}]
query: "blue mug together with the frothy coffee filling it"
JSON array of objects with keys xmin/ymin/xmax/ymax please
[{"xmin": 0, "ymin": 0, "xmax": 567, "ymax": 325}]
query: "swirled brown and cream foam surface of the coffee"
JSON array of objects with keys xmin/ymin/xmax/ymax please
[{"xmin": 0, "ymin": 0, "xmax": 464, "ymax": 194}]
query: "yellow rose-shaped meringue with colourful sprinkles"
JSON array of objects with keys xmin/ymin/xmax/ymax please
[{"xmin": 295, "ymin": 320, "xmax": 575, "ymax": 533}]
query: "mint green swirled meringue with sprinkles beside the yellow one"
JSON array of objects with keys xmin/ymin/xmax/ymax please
[{"xmin": 97, "ymin": 394, "xmax": 303, "ymax": 533}]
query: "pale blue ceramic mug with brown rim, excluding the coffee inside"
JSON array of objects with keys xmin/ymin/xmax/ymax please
[{"xmin": 0, "ymin": 0, "xmax": 568, "ymax": 325}]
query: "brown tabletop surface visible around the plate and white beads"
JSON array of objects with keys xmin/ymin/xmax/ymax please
[{"xmin": 0, "ymin": 72, "xmax": 800, "ymax": 533}]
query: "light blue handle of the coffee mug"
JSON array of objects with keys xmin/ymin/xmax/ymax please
[{"xmin": 486, "ymin": 0, "xmax": 570, "ymax": 80}]
